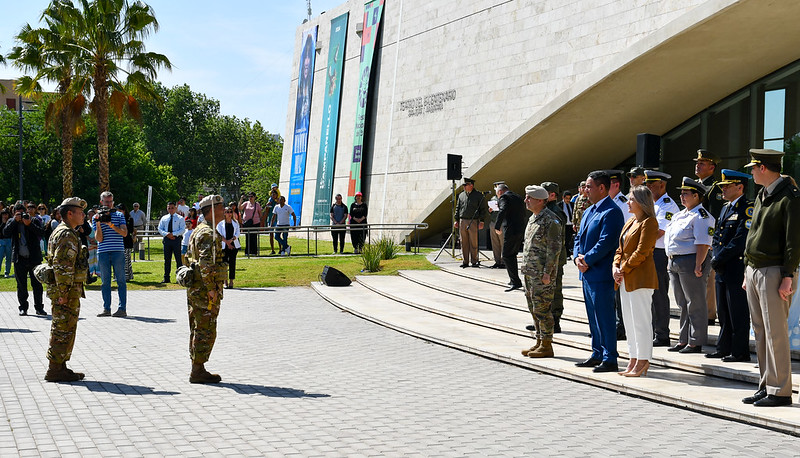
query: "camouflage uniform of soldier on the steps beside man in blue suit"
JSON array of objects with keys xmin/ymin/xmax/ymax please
[{"xmin": 521, "ymin": 208, "xmax": 564, "ymax": 340}]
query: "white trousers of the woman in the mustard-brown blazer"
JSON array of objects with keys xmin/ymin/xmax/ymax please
[{"xmin": 619, "ymin": 279, "xmax": 655, "ymax": 361}]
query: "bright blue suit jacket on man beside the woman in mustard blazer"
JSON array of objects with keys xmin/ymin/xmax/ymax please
[{"xmin": 574, "ymin": 198, "xmax": 625, "ymax": 282}]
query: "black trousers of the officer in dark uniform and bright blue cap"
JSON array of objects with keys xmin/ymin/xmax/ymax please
[{"xmin": 715, "ymin": 272, "xmax": 750, "ymax": 358}]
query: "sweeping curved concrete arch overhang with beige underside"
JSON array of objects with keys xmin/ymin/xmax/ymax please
[{"xmin": 419, "ymin": 0, "xmax": 800, "ymax": 236}]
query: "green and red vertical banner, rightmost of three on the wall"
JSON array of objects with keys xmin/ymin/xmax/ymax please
[{"xmin": 347, "ymin": 0, "xmax": 383, "ymax": 205}]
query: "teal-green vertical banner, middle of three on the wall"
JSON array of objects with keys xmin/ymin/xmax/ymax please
[{"xmin": 312, "ymin": 13, "xmax": 349, "ymax": 225}]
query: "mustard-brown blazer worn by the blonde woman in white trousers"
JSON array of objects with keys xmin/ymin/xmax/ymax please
[{"xmin": 614, "ymin": 216, "xmax": 658, "ymax": 292}]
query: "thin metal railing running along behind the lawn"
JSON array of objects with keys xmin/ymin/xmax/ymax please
[{"xmin": 137, "ymin": 223, "xmax": 428, "ymax": 260}]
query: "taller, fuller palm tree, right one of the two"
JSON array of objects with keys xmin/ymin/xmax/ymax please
[{"xmin": 69, "ymin": 0, "xmax": 172, "ymax": 192}]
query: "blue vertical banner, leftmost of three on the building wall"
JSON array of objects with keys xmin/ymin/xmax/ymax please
[{"xmin": 288, "ymin": 27, "xmax": 317, "ymax": 224}]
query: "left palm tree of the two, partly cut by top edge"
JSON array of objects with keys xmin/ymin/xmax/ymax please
[{"xmin": 8, "ymin": 0, "xmax": 86, "ymax": 198}]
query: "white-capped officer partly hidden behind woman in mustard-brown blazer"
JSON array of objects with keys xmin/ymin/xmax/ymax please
[{"xmin": 645, "ymin": 170, "xmax": 680, "ymax": 347}]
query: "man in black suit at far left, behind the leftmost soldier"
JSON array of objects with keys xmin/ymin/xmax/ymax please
[{"xmin": 3, "ymin": 203, "xmax": 47, "ymax": 316}]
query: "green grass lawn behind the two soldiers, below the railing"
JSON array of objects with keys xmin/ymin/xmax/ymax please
[{"xmin": 0, "ymin": 237, "xmax": 437, "ymax": 292}]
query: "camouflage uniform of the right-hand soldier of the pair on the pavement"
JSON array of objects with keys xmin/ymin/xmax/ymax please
[{"xmin": 185, "ymin": 221, "xmax": 228, "ymax": 364}]
